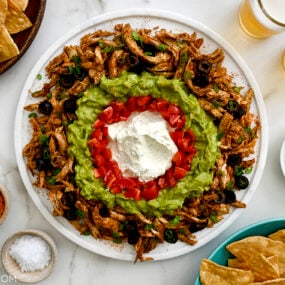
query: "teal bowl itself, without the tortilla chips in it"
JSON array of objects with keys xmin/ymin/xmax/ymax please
[{"xmin": 194, "ymin": 218, "xmax": 285, "ymax": 285}]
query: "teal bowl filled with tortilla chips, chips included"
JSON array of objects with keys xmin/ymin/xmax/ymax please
[{"xmin": 195, "ymin": 218, "xmax": 285, "ymax": 285}]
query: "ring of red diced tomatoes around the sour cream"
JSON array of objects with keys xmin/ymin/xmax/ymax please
[{"xmin": 88, "ymin": 95, "xmax": 196, "ymax": 201}]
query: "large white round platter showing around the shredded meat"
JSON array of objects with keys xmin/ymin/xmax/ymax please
[{"xmin": 14, "ymin": 9, "xmax": 268, "ymax": 261}]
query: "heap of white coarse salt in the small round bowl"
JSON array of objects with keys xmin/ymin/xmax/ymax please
[{"xmin": 9, "ymin": 234, "xmax": 51, "ymax": 272}]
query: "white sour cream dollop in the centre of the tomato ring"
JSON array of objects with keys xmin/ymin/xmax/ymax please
[{"xmin": 108, "ymin": 111, "xmax": 178, "ymax": 182}]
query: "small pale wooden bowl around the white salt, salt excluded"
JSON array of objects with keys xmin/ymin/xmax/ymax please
[{"xmin": 1, "ymin": 230, "xmax": 57, "ymax": 283}]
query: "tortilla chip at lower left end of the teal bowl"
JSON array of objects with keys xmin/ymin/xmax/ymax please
[{"xmin": 197, "ymin": 258, "xmax": 254, "ymax": 285}]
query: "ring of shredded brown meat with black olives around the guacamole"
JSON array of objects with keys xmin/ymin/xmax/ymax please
[{"xmin": 23, "ymin": 24, "xmax": 261, "ymax": 261}]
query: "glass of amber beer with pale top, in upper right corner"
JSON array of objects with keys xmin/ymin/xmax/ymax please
[{"xmin": 239, "ymin": 0, "xmax": 285, "ymax": 39}]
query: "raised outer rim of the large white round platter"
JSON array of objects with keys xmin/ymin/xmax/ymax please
[{"xmin": 14, "ymin": 9, "xmax": 268, "ymax": 261}]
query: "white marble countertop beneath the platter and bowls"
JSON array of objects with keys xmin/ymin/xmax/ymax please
[{"xmin": 0, "ymin": 0, "xmax": 285, "ymax": 285}]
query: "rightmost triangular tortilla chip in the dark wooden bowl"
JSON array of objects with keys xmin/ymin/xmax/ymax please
[{"xmin": 5, "ymin": 0, "xmax": 32, "ymax": 34}]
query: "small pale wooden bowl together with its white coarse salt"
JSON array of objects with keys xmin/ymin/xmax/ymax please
[{"xmin": 1, "ymin": 230, "xmax": 57, "ymax": 283}]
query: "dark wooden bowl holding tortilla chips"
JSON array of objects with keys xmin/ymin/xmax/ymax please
[{"xmin": 0, "ymin": 0, "xmax": 46, "ymax": 74}]
